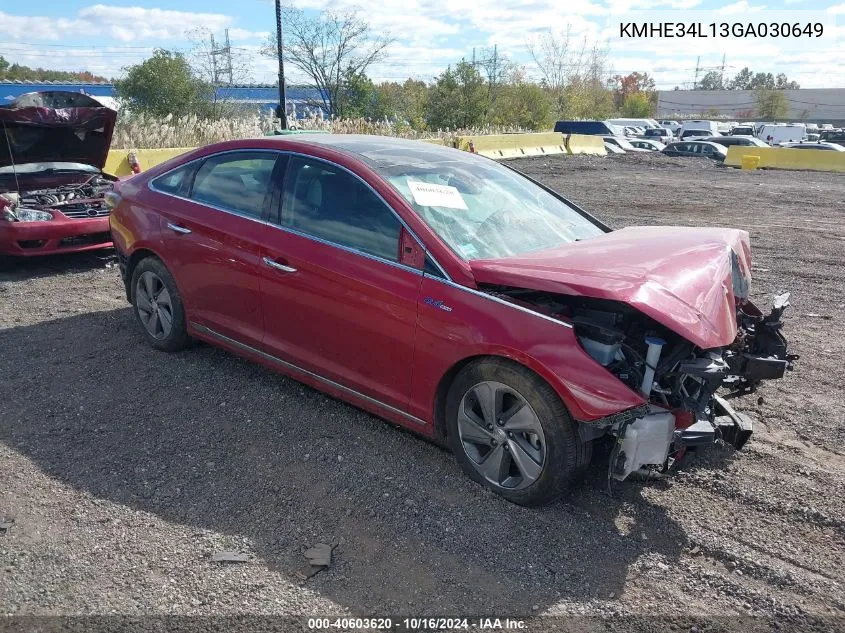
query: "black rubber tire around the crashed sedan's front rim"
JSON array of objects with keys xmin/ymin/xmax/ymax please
[{"xmin": 446, "ymin": 358, "xmax": 592, "ymax": 506}]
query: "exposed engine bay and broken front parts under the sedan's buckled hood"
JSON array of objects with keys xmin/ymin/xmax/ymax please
[{"xmin": 486, "ymin": 286, "xmax": 798, "ymax": 479}]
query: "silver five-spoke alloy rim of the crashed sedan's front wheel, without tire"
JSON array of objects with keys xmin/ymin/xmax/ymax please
[{"xmin": 458, "ymin": 381, "xmax": 546, "ymax": 490}]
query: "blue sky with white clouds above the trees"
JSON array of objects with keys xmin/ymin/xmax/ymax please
[{"xmin": 0, "ymin": 0, "xmax": 845, "ymax": 90}]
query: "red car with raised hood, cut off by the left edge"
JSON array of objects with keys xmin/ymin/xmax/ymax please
[{"xmin": 0, "ymin": 91, "xmax": 116, "ymax": 257}]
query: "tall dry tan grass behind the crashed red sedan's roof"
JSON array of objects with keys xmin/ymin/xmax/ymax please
[{"xmin": 112, "ymin": 112, "xmax": 524, "ymax": 149}]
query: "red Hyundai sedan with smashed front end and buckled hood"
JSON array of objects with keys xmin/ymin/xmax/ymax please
[{"xmin": 111, "ymin": 135, "xmax": 795, "ymax": 505}]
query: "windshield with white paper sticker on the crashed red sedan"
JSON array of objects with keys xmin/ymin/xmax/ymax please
[{"xmin": 380, "ymin": 154, "xmax": 604, "ymax": 261}]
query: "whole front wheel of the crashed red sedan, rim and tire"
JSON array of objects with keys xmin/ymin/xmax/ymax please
[{"xmin": 446, "ymin": 359, "xmax": 592, "ymax": 506}]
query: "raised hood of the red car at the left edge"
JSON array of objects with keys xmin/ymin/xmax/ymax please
[{"xmin": 0, "ymin": 91, "xmax": 117, "ymax": 169}]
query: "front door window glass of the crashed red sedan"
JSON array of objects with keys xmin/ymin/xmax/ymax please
[{"xmin": 281, "ymin": 158, "xmax": 401, "ymax": 261}]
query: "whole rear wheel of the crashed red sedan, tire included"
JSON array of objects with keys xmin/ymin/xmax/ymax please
[{"xmin": 131, "ymin": 257, "xmax": 188, "ymax": 352}]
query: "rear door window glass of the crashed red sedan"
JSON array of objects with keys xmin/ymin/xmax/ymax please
[{"xmin": 191, "ymin": 152, "xmax": 278, "ymax": 219}]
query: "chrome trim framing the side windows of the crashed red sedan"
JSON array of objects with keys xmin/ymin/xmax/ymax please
[{"xmin": 147, "ymin": 149, "xmax": 452, "ymax": 281}]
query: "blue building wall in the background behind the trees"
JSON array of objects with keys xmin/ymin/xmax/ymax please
[{"xmin": 0, "ymin": 81, "xmax": 322, "ymax": 116}]
